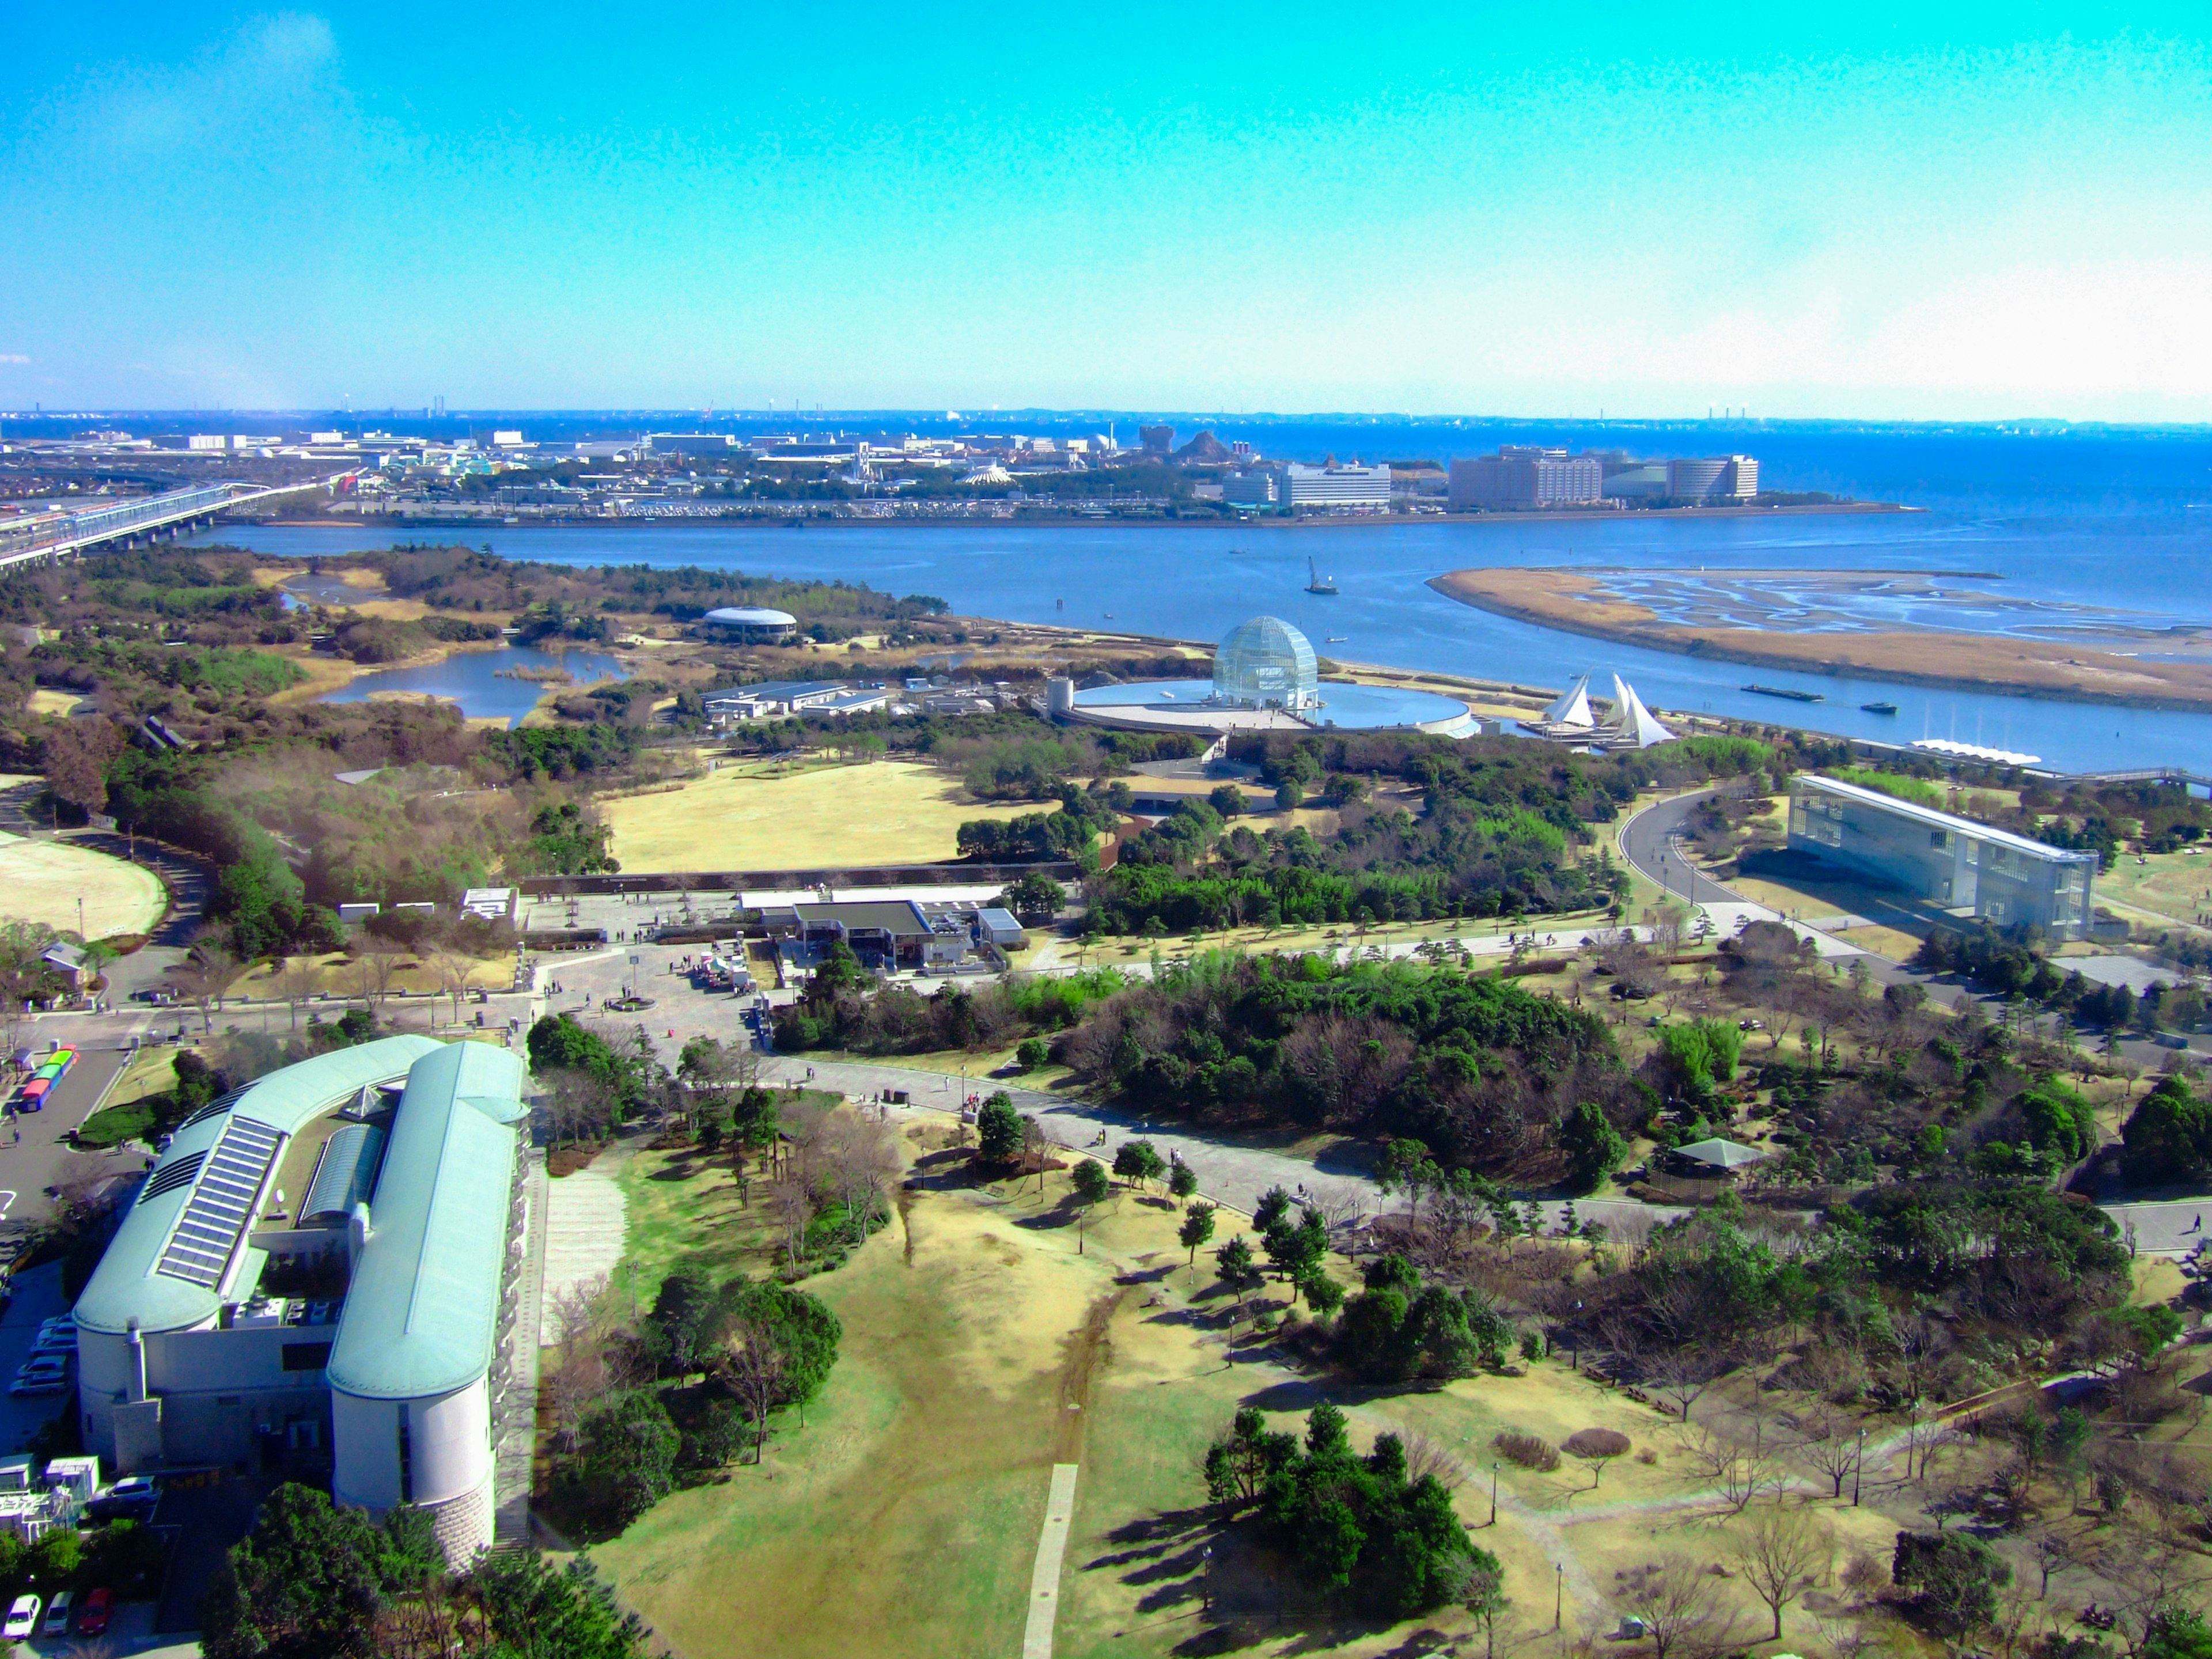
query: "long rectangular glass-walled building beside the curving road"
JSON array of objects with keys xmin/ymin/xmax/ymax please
[{"xmin": 1790, "ymin": 772, "xmax": 2097, "ymax": 938}]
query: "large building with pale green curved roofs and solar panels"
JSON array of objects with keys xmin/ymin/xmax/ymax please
[{"xmin": 75, "ymin": 1037, "xmax": 531, "ymax": 1564}]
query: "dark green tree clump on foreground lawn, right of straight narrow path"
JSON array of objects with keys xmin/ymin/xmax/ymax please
[{"xmin": 1206, "ymin": 1404, "xmax": 1502, "ymax": 1619}]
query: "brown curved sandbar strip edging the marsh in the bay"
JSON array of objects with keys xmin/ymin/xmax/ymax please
[{"xmin": 1429, "ymin": 571, "xmax": 2212, "ymax": 708}]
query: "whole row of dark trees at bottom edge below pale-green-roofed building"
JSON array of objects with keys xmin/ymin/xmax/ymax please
[{"xmin": 201, "ymin": 1484, "xmax": 650, "ymax": 1659}]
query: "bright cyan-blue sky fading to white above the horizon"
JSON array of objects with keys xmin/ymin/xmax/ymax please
[{"xmin": 0, "ymin": 0, "xmax": 2212, "ymax": 421}]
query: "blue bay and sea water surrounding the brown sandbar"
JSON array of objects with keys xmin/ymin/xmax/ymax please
[{"xmin": 194, "ymin": 418, "xmax": 2212, "ymax": 770}]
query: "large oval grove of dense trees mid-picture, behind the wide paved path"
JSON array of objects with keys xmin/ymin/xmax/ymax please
[{"xmin": 1058, "ymin": 953, "xmax": 1650, "ymax": 1177}]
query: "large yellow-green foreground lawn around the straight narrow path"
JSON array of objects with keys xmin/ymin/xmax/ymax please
[{"xmin": 575, "ymin": 1124, "xmax": 1955, "ymax": 1659}]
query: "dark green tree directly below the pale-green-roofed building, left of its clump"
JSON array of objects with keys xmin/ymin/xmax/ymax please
[{"xmin": 201, "ymin": 1484, "xmax": 442, "ymax": 1659}]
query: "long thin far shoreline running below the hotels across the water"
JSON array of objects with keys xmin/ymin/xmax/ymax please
[{"xmin": 247, "ymin": 502, "xmax": 1929, "ymax": 533}]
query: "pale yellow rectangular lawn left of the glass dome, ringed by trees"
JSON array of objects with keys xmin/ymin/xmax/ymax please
[{"xmin": 601, "ymin": 761, "xmax": 1046, "ymax": 874}]
